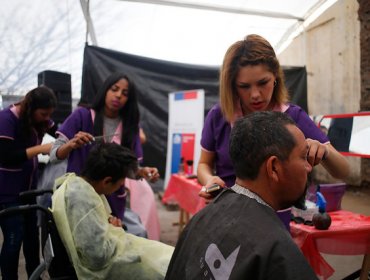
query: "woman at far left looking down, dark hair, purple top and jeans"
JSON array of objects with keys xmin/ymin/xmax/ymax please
[{"xmin": 0, "ymin": 86, "xmax": 57, "ymax": 280}]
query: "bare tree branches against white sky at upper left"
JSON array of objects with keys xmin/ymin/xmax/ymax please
[{"xmin": 0, "ymin": 1, "xmax": 84, "ymax": 94}]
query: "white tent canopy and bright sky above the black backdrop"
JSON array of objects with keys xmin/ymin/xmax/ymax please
[{"xmin": 0, "ymin": 0, "xmax": 335, "ymax": 98}]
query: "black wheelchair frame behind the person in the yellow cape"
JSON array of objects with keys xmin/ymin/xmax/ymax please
[{"xmin": 0, "ymin": 190, "xmax": 78, "ymax": 280}]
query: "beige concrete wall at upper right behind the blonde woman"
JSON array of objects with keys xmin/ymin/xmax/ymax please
[{"xmin": 278, "ymin": 0, "xmax": 361, "ymax": 185}]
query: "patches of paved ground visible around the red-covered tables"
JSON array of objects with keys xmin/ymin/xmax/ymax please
[{"xmin": 0, "ymin": 185, "xmax": 370, "ymax": 280}]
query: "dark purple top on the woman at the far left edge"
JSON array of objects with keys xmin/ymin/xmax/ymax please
[{"xmin": 0, "ymin": 108, "xmax": 41, "ymax": 203}]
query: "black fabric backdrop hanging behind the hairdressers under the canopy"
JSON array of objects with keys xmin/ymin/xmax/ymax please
[{"xmin": 80, "ymin": 45, "xmax": 307, "ymax": 177}]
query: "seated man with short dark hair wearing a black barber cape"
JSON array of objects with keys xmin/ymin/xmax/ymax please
[{"xmin": 165, "ymin": 112, "xmax": 317, "ymax": 280}]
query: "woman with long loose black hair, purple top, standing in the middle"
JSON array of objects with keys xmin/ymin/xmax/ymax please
[{"xmin": 51, "ymin": 73, "xmax": 159, "ymax": 239}]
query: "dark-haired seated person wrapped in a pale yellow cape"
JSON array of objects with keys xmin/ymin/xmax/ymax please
[{"xmin": 52, "ymin": 143, "xmax": 173, "ymax": 280}]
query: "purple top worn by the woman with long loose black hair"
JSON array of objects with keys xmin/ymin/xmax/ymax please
[{"xmin": 57, "ymin": 107, "xmax": 143, "ymax": 219}]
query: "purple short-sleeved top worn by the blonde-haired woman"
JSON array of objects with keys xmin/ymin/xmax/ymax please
[{"xmin": 200, "ymin": 104, "xmax": 329, "ymax": 187}]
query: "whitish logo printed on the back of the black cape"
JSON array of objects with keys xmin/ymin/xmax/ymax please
[{"xmin": 205, "ymin": 243, "xmax": 240, "ymax": 280}]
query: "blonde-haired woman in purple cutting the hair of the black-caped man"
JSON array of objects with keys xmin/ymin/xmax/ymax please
[{"xmin": 197, "ymin": 34, "xmax": 349, "ymax": 199}]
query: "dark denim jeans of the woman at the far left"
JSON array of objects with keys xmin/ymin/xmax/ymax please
[{"xmin": 0, "ymin": 203, "xmax": 40, "ymax": 280}]
